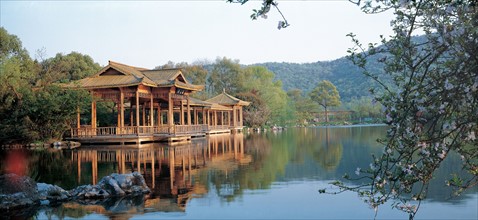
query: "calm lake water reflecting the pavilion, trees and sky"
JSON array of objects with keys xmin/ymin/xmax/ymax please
[{"xmin": 0, "ymin": 126, "xmax": 478, "ymax": 219}]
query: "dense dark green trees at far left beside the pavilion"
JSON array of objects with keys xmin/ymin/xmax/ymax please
[{"xmin": 0, "ymin": 28, "xmax": 95, "ymax": 143}]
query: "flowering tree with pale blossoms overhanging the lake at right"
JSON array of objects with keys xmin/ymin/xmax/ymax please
[{"xmin": 328, "ymin": 0, "xmax": 478, "ymax": 219}]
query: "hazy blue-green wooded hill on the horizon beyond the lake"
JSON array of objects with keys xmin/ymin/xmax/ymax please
[{"xmin": 253, "ymin": 57, "xmax": 383, "ymax": 101}]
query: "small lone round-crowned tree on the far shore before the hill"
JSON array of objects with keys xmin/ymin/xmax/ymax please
[{"xmin": 309, "ymin": 80, "xmax": 341, "ymax": 122}]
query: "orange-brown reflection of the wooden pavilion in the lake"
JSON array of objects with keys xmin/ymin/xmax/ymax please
[{"xmin": 71, "ymin": 133, "xmax": 252, "ymax": 211}]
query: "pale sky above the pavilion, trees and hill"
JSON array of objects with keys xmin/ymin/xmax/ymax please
[{"xmin": 0, "ymin": 0, "xmax": 392, "ymax": 68}]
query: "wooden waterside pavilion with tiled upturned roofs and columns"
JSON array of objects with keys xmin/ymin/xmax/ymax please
[{"xmin": 67, "ymin": 61, "xmax": 249, "ymax": 144}]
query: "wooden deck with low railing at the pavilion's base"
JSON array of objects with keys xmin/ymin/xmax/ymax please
[{"xmin": 68, "ymin": 125, "xmax": 242, "ymax": 145}]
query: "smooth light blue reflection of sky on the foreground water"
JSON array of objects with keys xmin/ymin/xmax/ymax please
[{"xmin": 146, "ymin": 181, "xmax": 478, "ymax": 219}]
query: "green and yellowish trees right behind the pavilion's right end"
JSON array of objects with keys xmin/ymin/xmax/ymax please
[{"xmin": 166, "ymin": 57, "xmax": 294, "ymax": 127}]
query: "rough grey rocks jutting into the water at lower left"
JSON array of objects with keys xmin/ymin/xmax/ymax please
[{"xmin": 0, "ymin": 172, "xmax": 150, "ymax": 212}]
